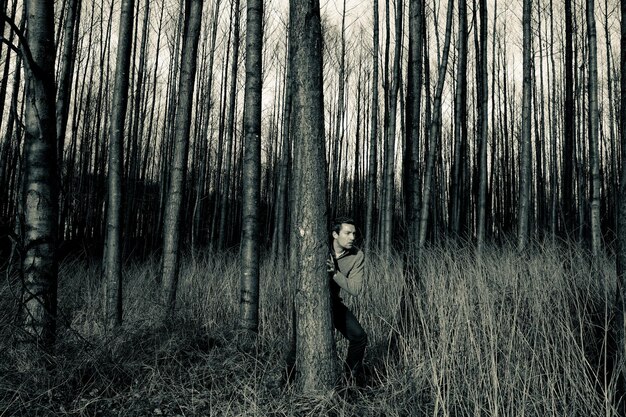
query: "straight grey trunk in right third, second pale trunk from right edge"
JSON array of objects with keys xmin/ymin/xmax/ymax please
[{"xmin": 517, "ymin": 0, "xmax": 532, "ymax": 250}]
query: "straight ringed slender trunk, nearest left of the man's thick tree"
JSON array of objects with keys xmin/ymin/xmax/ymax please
[{"xmin": 239, "ymin": 0, "xmax": 263, "ymax": 340}]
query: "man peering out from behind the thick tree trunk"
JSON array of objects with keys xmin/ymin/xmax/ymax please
[{"xmin": 327, "ymin": 217, "xmax": 367, "ymax": 382}]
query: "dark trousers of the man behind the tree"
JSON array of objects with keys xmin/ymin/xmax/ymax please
[{"xmin": 331, "ymin": 299, "xmax": 367, "ymax": 375}]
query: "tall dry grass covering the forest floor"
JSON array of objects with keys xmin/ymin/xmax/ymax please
[{"xmin": 0, "ymin": 240, "xmax": 616, "ymax": 417}]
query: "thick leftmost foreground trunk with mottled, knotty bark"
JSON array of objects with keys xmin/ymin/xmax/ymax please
[{"xmin": 21, "ymin": 0, "xmax": 59, "ymax": 348}]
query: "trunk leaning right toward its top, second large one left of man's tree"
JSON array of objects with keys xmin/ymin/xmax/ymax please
[{"xmin": 161, "ymin": 0, "xmax": 202, "ymax": 320}]
